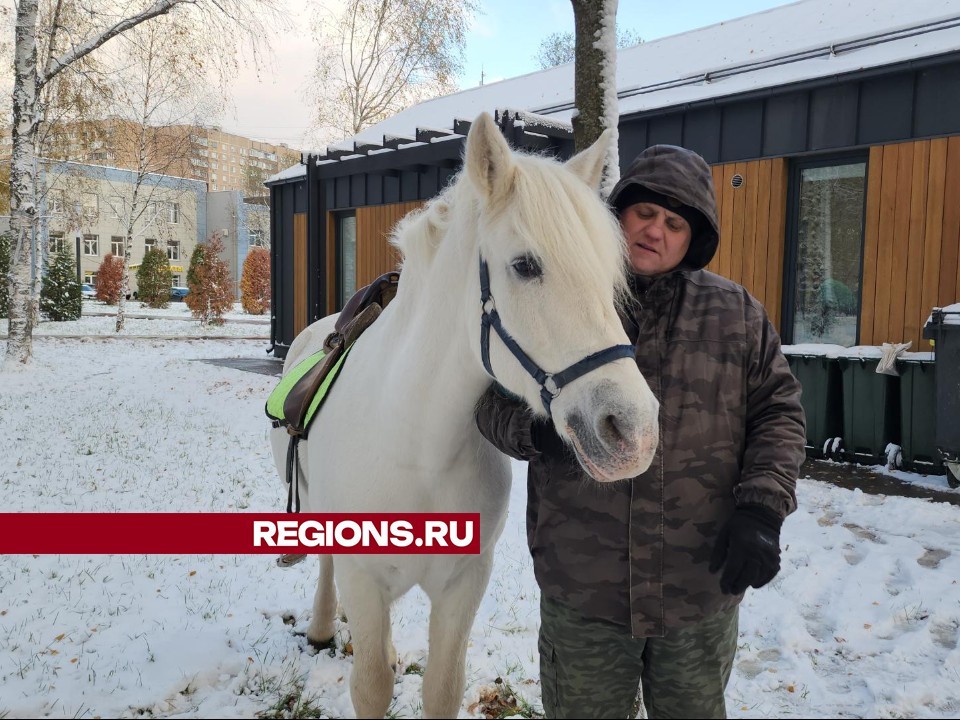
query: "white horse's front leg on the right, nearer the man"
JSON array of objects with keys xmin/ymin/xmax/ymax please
[{"xmin": 423, "ymin": 553, "xmax": 493, "ymax": 718}]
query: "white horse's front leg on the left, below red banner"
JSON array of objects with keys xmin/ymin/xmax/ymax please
[{"xmin": 338, "ymin": 564, "xmax": 396, "ymax": 718}]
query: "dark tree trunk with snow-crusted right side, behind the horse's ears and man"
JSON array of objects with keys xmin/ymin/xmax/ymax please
[{"xmin": 570, "ymin": 0, "xmax": 620, "ymax": 196}]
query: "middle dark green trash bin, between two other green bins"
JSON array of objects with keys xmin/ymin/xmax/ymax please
[{"xmin": 837, "ymin": 356, "xmax": 900, "ymax": 465}]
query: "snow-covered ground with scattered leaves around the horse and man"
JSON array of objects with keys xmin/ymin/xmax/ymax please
[{"xmin": 0, "ymin": 318, "xmax": 960, "ymax": 718}]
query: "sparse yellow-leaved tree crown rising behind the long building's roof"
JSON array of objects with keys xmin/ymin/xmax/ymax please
[{"xmin": 313, "ymin": 0, "xmax": 476, "ymax": 137}]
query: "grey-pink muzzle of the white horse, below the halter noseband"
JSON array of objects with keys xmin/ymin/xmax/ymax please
[{"xmin": 562, "ymin": 383, "xmax": 660, "ymax": 482}]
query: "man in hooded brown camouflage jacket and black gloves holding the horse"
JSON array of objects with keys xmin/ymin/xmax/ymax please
[{"xmin": 477, "ymin": 145, "xmax": 804, "ymax": 718}]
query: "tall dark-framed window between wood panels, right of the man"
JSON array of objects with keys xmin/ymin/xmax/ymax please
[{"xmin": 784, "ymin": 158, "xmax": 867, "ymax": 347}]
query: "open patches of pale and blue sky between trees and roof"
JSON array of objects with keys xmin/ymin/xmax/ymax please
[{"xmin": 221, "ymin": 0, "xmax": 800, "ymax": 149}]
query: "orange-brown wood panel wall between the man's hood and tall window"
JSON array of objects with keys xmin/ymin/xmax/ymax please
[{"xmin": 707, "ymin": 158, "xmax": 787, "ymax": 331}]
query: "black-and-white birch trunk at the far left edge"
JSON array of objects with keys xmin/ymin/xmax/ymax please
[{"xmin": 6, "ymin": 0, "xmax": 38, "ymax": 365}]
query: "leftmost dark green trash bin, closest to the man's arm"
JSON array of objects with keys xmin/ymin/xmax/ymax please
[{"xmin": 784, "ymin": 353, "xmax": 843, "ymax": 458}]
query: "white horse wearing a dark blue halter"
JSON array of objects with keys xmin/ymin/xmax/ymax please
[{"xmin": 271, "ymin": 114, "xmax": 658, "ymax": 717}]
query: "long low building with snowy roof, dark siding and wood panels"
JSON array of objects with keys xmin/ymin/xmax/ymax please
[{"xmin": 268, "ymin": 0, "xmax": 960, "ymax": 355}]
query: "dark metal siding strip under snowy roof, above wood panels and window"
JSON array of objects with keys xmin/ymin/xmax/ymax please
[{"xmin": 620, "ymin": 53, "xmax": 960, "ymax": 169}]
